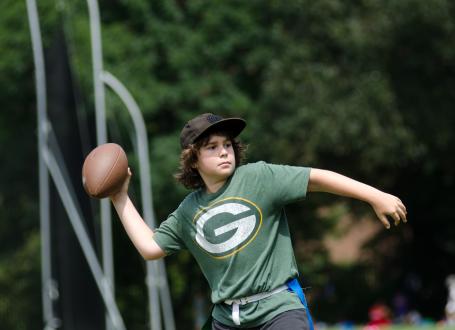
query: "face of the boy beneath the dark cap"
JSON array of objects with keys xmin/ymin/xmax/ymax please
[{"xmin": 196, "ymin": 135, "xmax": 236, "ymax": 184}]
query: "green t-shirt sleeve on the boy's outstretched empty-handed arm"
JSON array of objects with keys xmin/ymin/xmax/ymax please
[{"xmin": 263, "ymin": 163, "xmax": 311, "ymax": 205}]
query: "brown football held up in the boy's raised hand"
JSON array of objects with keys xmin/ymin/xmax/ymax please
[{"xmin": 82, "ymin": 143, "xmax": 128, "ymax": 198}]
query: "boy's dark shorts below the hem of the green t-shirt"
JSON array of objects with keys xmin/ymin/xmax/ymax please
[{"xmin": 212, "ymin": 308, "xmax": 310, "ymax": 330}]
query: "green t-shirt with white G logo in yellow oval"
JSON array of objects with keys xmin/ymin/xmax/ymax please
[{"xmin": 154, "ymin": 162, "xmax": 310, "ymax": 327}]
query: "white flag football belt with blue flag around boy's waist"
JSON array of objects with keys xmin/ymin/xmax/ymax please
[{"xmin": 224, "ymin": 279, "xmax": 314, "ymax": 330}]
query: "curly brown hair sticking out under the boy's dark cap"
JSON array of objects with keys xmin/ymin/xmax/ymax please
[{"xmin": 174, "ymin": 131, "xmax": 247, "ymax": 189}]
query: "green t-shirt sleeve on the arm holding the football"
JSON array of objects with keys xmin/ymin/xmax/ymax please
[{"xmin": 153, "ymin": 212, "xmax": 185, "ymax": 255}]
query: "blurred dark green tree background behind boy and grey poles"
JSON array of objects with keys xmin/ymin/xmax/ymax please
[{"xmin": 0, "ymin": 0, "xmax": 455, "ymax": 329}]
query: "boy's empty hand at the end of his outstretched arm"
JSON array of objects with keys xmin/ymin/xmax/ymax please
[{"xmin": 371, "ymin": 191, "xmax": 408, "ymax": 229}]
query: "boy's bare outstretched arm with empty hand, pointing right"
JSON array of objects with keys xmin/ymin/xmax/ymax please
[{"xmin": 308, "ymin": 168, "xmax": 407, "ymax": 229}]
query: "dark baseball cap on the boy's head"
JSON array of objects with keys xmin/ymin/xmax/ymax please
[{"xmin": 180, "ymin": 113, "xmax": 246, "ymax": 149}]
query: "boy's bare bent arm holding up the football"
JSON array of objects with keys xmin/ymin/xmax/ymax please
[{"xmin": 110, "ymin": 169, "xmax": 166, "ymax": 260}]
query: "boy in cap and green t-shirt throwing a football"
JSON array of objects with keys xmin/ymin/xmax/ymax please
[{"xmin": 111, "ymin": 114, "xmax": 406, "ymax": 330}]
